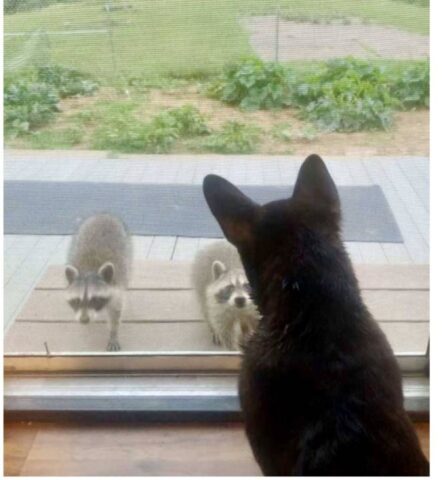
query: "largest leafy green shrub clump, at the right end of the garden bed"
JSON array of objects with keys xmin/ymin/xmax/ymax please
[{"xmin": 294, "ymin": 58, "xmax": 430, "ymax": 132}]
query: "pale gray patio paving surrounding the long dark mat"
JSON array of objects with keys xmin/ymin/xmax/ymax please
[{"xmin": 4, "ymin": 151, "xmax": 429, "ymax": 329}]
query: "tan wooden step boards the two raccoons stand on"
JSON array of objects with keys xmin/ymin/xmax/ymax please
[{"xmin": 4, "ymin": 260, "xmax": 429, "ymax": 355}]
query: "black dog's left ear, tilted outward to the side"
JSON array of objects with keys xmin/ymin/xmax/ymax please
[{"xmin": 203, "ymin": 175, "xmax": 259, "ymax": 246}]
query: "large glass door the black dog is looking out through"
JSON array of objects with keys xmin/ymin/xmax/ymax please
[{"xmin": 4, "ymin": 0, "xmax": 429, "ymax": 411}]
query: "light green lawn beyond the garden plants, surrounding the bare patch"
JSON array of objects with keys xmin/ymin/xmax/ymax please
[{"xmin": 4, "ymin": 0, "xmax": 429, "ymax": 81}]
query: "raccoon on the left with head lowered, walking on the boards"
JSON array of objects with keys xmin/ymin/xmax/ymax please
[{"xmin": 65, "ymin": 213, "xmax": 132, "ymax": 351}]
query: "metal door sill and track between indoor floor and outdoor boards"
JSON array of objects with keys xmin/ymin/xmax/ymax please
[{"xmin": 4, "ymin": 350, "xmax": 429, "ymax": 420}]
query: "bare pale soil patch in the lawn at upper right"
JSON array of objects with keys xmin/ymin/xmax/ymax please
[{"xmin": 243, "ymin": 15, "xmax": 429, "ymax": 61}]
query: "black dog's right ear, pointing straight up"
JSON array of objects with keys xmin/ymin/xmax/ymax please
[{"xmin": 293, "ymin": 154, "xmax": 341, "ymax": 223}]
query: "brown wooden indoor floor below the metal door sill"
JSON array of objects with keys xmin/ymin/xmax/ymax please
[{"xmin": 4, "ymin": 422, "xmax": 429, "ymax": 476}]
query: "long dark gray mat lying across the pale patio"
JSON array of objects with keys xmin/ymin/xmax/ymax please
[{"xmin": 4, "ymin": 181, "xmax": 403, "ymax": 243}]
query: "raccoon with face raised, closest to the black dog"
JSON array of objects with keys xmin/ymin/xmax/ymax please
[{"xmin": 192, "ymin": 241, "xmax": 259, "ymax": 350}]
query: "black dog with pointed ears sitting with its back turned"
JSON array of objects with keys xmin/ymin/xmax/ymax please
[{"xmin": 204, "ymin": 155, "xmax": 429, "ymax": 476}]
